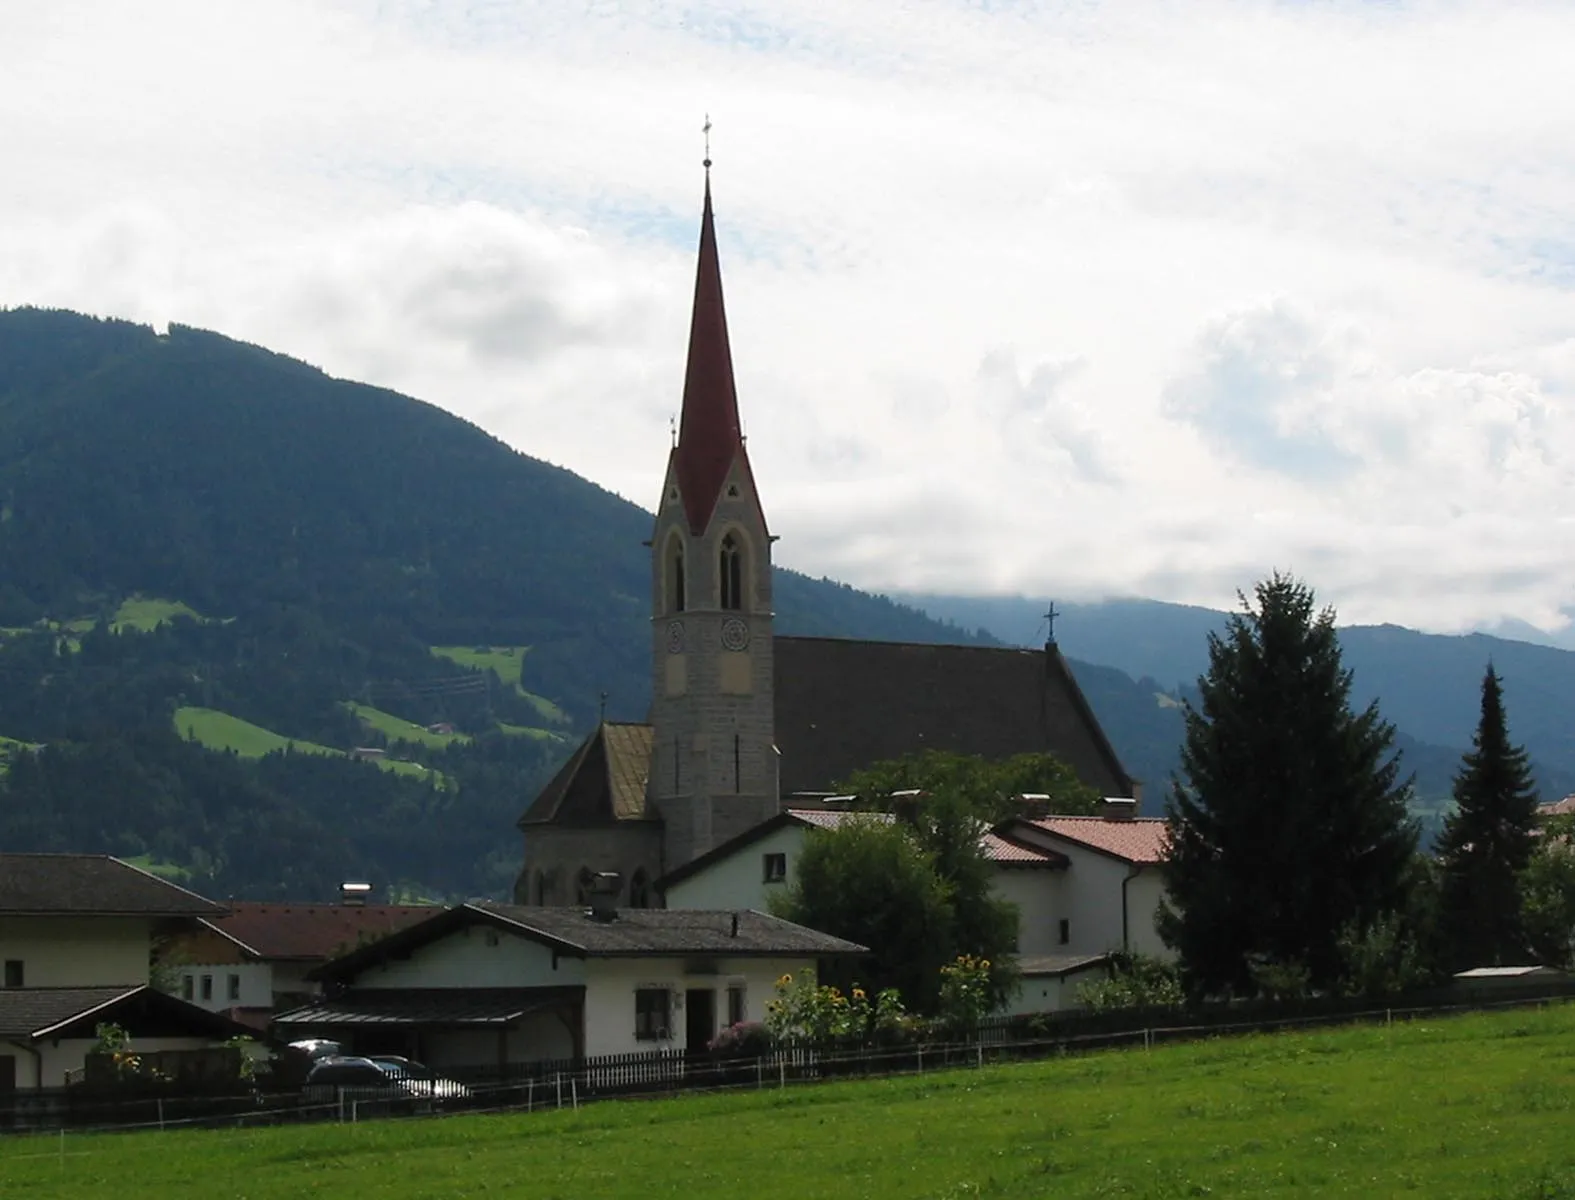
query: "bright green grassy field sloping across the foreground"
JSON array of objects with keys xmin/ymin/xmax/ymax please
[{"xmin": 0, "ymin": 1006, "xmax": 1575, "ymax": 1200}]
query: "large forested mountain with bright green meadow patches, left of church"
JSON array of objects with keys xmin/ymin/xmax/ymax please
[{"xmin": 0, "ymin": 309, "xmax": 988, "ymax": 898}]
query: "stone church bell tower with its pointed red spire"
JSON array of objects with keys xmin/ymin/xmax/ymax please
[{"xmin": 646, "ymin": 173, "xmax": 778, "ymax": 871}]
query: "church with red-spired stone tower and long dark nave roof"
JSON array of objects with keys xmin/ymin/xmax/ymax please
[{"xmin": 515, "ymin": 173, "xmax": 1137, "ymax": 907}]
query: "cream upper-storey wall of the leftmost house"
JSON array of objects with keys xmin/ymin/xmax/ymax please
[{"xmin": 0, "ymin": 917, "xmax": 151, "ymax": 982}]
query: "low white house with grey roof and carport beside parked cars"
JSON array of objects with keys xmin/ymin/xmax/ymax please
[{"xmin": 272, "ymin": 880, "xmax": 865, "ymax": 1074}]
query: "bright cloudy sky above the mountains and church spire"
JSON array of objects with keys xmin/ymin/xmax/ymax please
[{"xmin": 0, "ymin": 0, "xmax": 1575, "ymax": 647}]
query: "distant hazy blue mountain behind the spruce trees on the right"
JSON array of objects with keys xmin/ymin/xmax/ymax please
[{"xmin": 896, "ymin": 580, "xmax": 1575, "ymax": 813}]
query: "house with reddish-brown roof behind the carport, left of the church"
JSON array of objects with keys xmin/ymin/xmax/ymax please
[{"xmin": 162, "ymin": 901, "xmax": 438, "ymax": 1028}]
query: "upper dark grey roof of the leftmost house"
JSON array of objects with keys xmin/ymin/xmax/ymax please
[{"xmin": 0, "ymin": 854, "xmax": 224, "ymax": 917}]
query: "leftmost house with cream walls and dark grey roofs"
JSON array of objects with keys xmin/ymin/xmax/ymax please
[{"xmin": 0, "ymin": 854, "xmax": 255, "ymax": 1093}]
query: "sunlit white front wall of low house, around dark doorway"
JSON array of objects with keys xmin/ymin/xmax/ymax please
[{"xmin": 586, "ymin": 957, "xmax": 800, "ymax": 1055}]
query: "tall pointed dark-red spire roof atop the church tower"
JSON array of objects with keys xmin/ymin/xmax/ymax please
[{"xmin": 673, "ymin": 175, "xmax": 743, "ymax": 534}]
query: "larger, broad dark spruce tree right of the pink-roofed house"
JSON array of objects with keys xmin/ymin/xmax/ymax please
[{"xmin": 1161, "ymin": 573, "xmax": 1416, "ymax": 994}]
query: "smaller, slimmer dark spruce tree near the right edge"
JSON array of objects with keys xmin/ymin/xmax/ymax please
[{"xmin": 1433, "ymin": 663, "xmax": 1537, "ymax": 970}]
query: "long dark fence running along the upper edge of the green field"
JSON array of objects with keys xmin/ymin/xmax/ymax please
[{"xmin": 0, "ymin": 986, "xmax": 1575, "ymax": 1134}]
